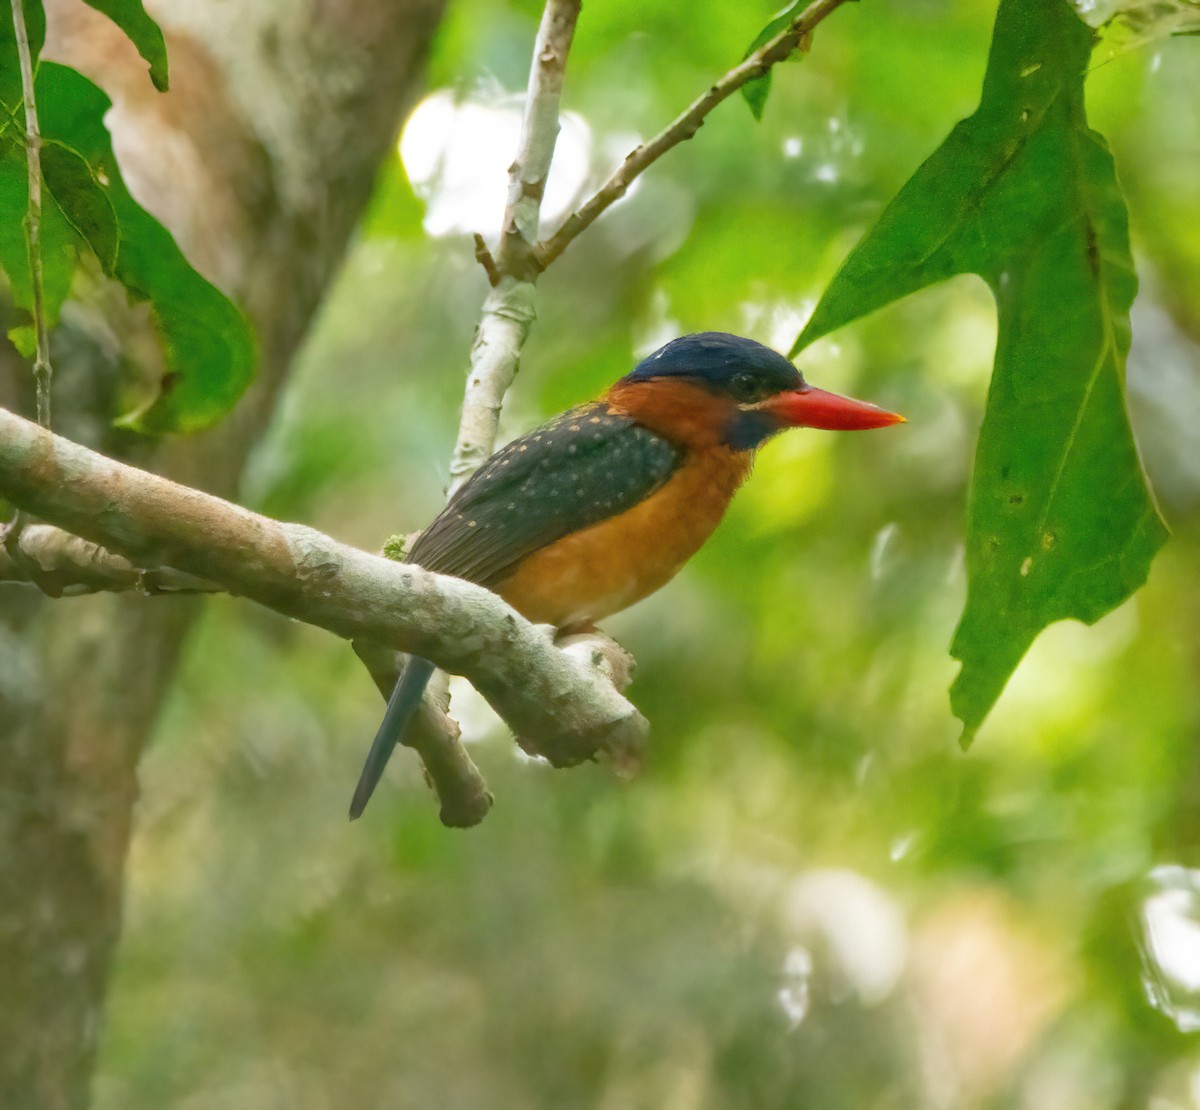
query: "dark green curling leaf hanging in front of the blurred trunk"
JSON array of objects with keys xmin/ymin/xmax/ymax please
[{"xmin": 37, "ymin": 62, "xmax": 254, "ymax": 433}]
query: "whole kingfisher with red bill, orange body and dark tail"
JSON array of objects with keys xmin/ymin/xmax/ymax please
[{"xmin": 350, "ymin": 331, "xmax": 904, "ymax": 821}]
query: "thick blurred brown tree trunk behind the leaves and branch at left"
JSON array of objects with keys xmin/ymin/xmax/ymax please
[{"xmin": 0, "ymin": 0, "xmax": 445, "ymax": 1110}]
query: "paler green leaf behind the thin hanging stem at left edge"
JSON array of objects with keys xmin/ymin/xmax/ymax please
[{"xmin": 0, "ymin": 128, "xmax": 77, "ymax": 359}]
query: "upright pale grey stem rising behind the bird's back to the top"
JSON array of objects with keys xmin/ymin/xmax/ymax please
[{"xmin": 450, "ymin": 0, "xmax": 581, "ymax": 493}]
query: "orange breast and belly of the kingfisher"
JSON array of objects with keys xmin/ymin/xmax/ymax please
[{"xmin": 496, "ymin": 445, "xmax": 751, "ymax": 628}]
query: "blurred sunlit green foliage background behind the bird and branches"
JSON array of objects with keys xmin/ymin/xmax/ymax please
[{"xmin": 97, "ymin": 0, "xmax": 1200, "ymax": 1110}]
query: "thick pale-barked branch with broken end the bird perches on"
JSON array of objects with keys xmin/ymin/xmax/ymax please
[{"xmin": 0, "ymin": 408, "xmax": 646, "ymax": 767}]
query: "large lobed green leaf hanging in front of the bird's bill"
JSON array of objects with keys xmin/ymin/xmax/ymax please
[{"xmin": 793, "ymin": 0, "xmax": 1166, "ymax": 743}]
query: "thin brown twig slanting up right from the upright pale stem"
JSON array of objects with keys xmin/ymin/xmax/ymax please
[{"xmin": 534, "ymin": 0, "xmax": 847, "ymax": 270}]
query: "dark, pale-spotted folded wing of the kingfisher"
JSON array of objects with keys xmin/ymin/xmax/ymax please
[{"xmin": 410, "ymin": 402, "xmax": 682, "ymax": 588}]
